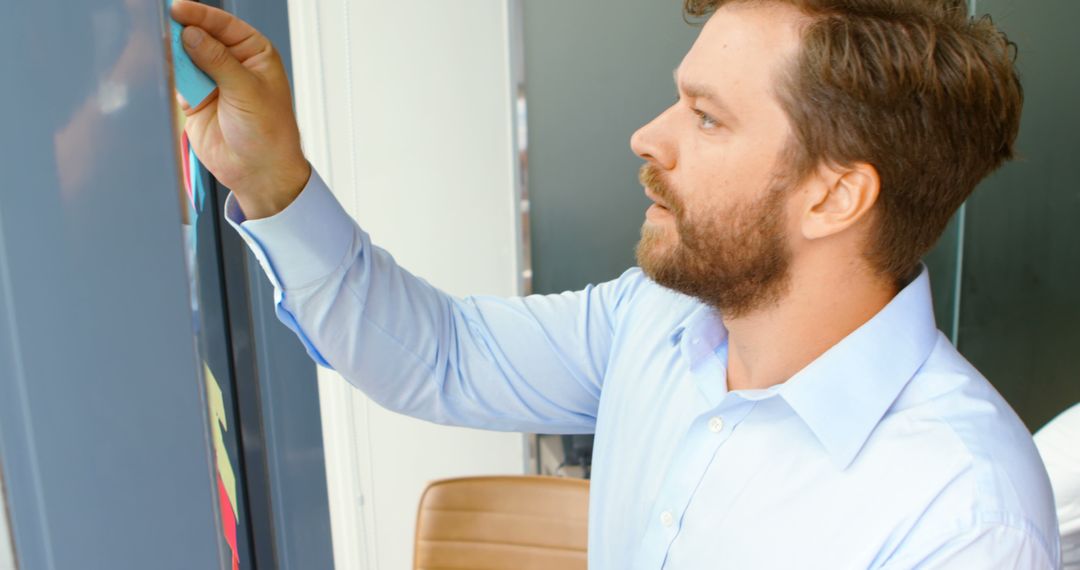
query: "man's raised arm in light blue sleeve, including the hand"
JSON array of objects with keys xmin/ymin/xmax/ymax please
[{"xmin": 173, "ymin": 2, "xmax": 634, "ymax": 433}]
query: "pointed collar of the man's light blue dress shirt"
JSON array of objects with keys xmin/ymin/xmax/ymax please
[{"xmin": 671, "ymin": 266, "xmax": 939, "ymax": 470}]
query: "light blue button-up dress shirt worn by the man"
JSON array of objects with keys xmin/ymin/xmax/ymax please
[{"xmin": 226, "ymin": 175, "xmax": 1059, "ymax": 570}]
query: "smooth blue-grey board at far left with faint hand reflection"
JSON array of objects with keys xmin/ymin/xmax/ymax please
[{"xmin": 0, "ymin": 0, "xmax": 221, "ymax": 570}]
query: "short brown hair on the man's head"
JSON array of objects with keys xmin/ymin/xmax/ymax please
[{"xmin": 684, "ymin": 0, "xmax": 1023, "ymax": 281}]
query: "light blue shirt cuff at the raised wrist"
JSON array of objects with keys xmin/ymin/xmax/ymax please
[{"xmin": 225, "ymin": 168, "xmax": 355, "ymax": 290}]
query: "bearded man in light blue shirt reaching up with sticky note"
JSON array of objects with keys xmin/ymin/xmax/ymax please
[{"xmin": 174, "ymin": 0, "xmax": 1059, "ymax": 570}]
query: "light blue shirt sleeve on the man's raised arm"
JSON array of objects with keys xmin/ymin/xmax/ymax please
[{"xmin": 226, "ymin": 173, "xmax": 642, "ymax": 433}]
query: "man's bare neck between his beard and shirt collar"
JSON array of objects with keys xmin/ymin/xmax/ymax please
[{"xmin": 724, "ymin": 258, "xmax": 897, "ymax": 391}]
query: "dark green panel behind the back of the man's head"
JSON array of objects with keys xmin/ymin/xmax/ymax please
[{"xmin": 960, "ymin": 0, "xmax": 1080, "ymax": 430}]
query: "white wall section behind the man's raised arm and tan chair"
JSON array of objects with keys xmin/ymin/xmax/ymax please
[{"xmin": 289, "ymin": 0, "xmax": 524, "ymax": 570}]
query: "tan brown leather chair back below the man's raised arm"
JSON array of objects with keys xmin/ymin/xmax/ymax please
[{"xmin": 413, "ymin": 476, "xmax": 589, "ymax": 570}]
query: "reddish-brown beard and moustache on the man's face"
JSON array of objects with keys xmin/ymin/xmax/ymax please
[{"xmin": 636, "ymin": 164, "xmax": 792, "ymax": 318}]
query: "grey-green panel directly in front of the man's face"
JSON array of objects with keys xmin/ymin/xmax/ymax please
[{"xmin": 523, "ymin": 0, "xmax": 698, "ymax": 293}]
